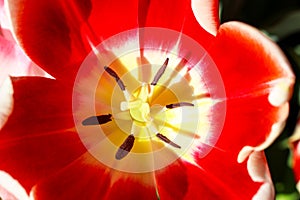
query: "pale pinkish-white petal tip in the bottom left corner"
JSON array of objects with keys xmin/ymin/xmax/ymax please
[{"xmin": 0, "ymin": 171, "xmax": 29, "ymax": 200}]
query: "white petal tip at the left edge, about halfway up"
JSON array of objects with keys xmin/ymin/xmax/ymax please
[{"xmin": 0, "ymin": 78, "xmax": 14, "ymax": 129}]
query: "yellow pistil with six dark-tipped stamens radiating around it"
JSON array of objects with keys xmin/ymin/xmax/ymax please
[{"xmin": 104, "ymin": 58, "xmax": 186, "ymax": 160}]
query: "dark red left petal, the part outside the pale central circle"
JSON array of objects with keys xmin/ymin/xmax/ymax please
[{"xmin": 0, "ymin": 78, "xmax": 85, "ymax": 192}]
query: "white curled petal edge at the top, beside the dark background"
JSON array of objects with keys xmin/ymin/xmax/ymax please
[{"xmin": 191, "ymin": 0, "xmax": 219, "ymax": 36}]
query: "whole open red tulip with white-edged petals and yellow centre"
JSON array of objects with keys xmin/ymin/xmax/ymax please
[{"xmin": 0, "ymin": 0, "xmax": 294, "ymax": 199}]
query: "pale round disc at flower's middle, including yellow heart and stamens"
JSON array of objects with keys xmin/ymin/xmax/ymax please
[{"xmin": 73, "ymin": 28, "xmax": 225, "ymax": 173}]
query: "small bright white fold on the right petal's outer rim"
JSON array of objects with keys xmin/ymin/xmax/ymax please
[{"xmin": 268, "ymin": 79, "xmax": 293, "ymax": 107}]
